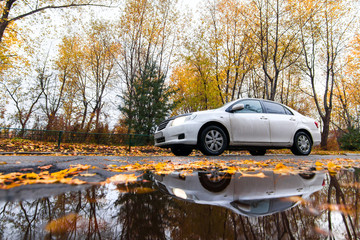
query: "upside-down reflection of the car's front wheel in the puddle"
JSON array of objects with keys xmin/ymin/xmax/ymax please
[{"xmin": 198, "ymin": 171, "xmax": 231, "ymax": 192}]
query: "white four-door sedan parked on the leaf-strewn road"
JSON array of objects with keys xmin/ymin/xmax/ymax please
[{"xmin": 154, "ymin": 98, "xmax": 321, "ymax": 156}]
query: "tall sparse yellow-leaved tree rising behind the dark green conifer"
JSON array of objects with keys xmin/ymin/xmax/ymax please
[{"xmin": 117, "ymin": 0, "xmax": 177, "ymax": 133}]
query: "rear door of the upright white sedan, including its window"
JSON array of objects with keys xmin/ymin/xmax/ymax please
[{"xmin": 262, "ymin": 101, "xmax": 298, "ymax": 146}]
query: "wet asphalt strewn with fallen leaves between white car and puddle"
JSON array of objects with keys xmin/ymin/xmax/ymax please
[{"xmin": 0, "ymin": 154, "xmax": 360, "ymax": 202}]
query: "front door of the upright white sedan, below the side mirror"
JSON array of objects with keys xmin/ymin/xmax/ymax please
[{"xmin": 230, "ymin": 99, "xmax": 270, "ymax": 146}]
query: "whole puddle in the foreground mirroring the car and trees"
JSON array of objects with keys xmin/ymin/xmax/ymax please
[{"xmin": 0, "ymin": 169, "xmax": 360, "ymax": 239}]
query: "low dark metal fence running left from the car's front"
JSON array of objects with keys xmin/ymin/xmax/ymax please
[{"xmin": 0, "ymin": 128, "xmax": 153, "ymax": 147}]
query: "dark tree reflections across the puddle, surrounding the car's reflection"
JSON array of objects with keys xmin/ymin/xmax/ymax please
[{"xmin": 0, "ymin": 170, "xmax": 360, "ymax": 239}]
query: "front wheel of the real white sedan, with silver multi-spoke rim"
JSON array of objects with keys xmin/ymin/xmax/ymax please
[{"xmin": 199, "ymin": 126, "xmax": 228, "ymax": 156}]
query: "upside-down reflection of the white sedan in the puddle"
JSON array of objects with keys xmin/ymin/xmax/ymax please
[{"xmin": 154, "ymin": 171, "xmax": 325, "ymax": 216}]
